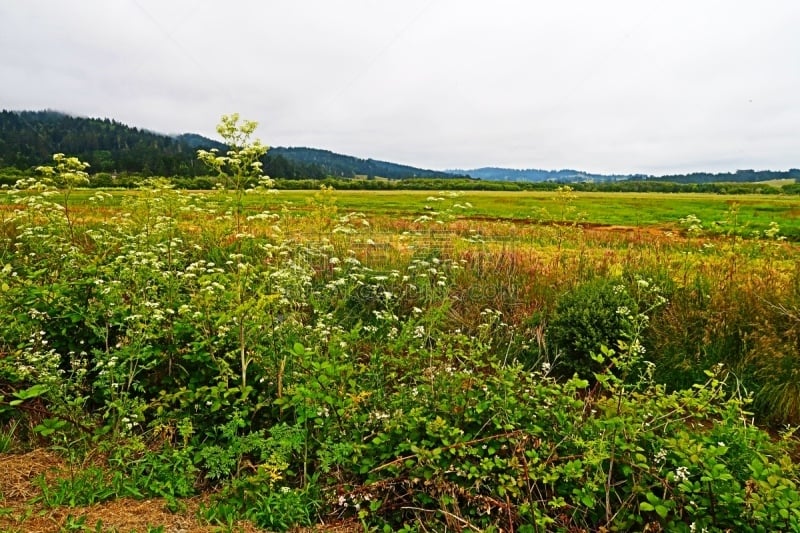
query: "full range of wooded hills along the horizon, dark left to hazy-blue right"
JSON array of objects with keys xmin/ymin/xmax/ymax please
[{"xmin": 0, "ymin": 110, "xmax": 800, "ymax": 183}]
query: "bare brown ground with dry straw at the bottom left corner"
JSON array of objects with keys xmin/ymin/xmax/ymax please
[{"xmin": 0, "ymin": 450, "xmax": 361, "ymax": 533}]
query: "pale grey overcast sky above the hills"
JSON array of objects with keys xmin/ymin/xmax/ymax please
[{"xmin": 0, "ymin": 0, "xmax": 800, "ymax": 174}]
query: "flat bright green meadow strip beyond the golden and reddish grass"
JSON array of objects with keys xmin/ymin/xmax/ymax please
[{"xmin": 6, "ymin": 187, "xmax": 800, "ymax": 240}]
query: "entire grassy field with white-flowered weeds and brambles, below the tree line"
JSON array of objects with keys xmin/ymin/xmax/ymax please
[{"xmin": 0, "ymin": 188, "xmax": 800, "ymax": 532}]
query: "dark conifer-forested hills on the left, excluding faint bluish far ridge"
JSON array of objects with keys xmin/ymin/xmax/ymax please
[{"xmin": 0, "ymin": 110, "xmax": 462, "ymax": 179}]
